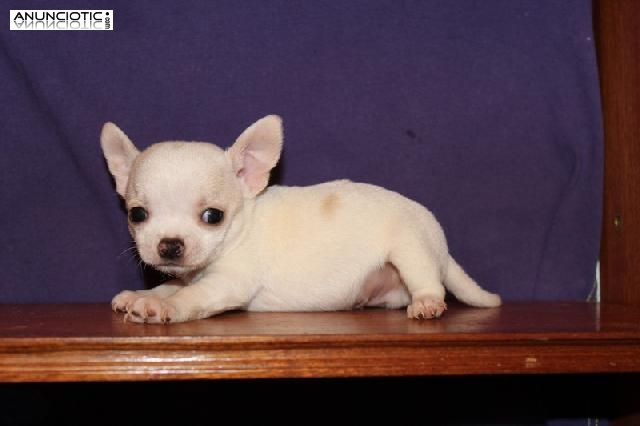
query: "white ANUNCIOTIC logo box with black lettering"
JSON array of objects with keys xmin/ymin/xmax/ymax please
[{"xmin": 9, "ymin": 10, "xmax": 113, "ymax": 30}]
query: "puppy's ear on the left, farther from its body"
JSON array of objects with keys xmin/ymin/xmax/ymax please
[{"xmin": 100, "ymin": 123, "xmax": 140, "ymax": 198}]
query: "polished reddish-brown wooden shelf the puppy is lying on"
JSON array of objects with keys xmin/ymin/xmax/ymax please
[{"xmin": 0, "ymin": 302, "xmax": 640, "ymax": 382}]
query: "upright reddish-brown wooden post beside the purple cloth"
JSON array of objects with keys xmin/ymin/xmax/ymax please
[{"xmin": 594, "ymin": 0, "xmax": 640, "ymax": 306}]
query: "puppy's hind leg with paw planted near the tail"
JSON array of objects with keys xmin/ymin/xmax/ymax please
[{"xmin": 389, "ymin": 236, "xmax": 447, "ymax": 318}]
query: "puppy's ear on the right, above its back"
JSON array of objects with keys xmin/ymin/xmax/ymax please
[{"xmin": 227, "ymin": 115, "xmax": 282, "ymax": 197}]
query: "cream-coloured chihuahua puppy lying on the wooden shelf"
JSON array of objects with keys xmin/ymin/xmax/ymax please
[{"xmin": 101, "ymin": 115, "xmax": 500, "ymax": 323}]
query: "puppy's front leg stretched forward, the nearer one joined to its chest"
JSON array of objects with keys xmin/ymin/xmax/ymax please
[{"xmin": 127, "ymin": 274, "xmax": 252, "ymax": 324}]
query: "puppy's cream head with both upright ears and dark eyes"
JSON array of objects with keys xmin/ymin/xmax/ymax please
[{"xmin": 100, "ymin": 115, "xmax": 282, "ymax": 276}]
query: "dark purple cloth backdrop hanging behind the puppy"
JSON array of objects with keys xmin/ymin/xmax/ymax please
[{"xmin": 0, "ymin": 0, "xmax": 603, "ymax": 302}]
